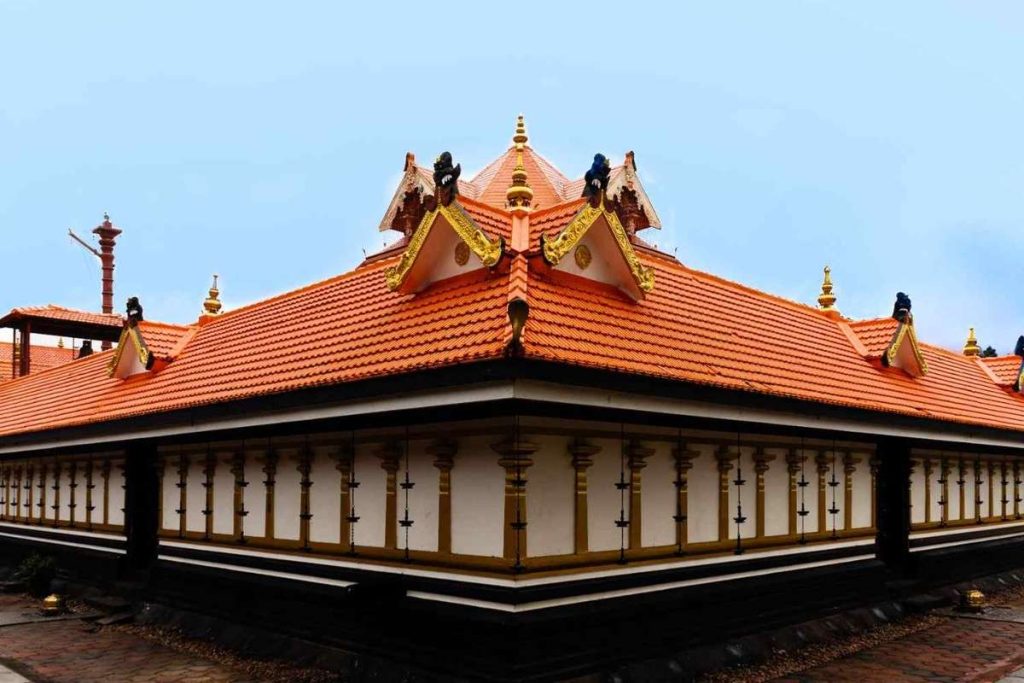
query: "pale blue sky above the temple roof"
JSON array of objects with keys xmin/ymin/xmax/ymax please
[{"xmin": 0, "ymin": 0, "xmax": 1024, "ymax": 352}]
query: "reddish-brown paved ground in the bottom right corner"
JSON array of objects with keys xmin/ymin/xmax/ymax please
[{"xmin": 776, "ymin": 616, "xmax": 1024, "ymax": 683}]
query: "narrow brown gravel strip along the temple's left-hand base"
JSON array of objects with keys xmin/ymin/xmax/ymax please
[{"xmin": 105, "ymin": 624, "xmax": 343, "ymax": 683}]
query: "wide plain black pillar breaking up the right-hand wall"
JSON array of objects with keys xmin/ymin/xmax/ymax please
[{"xmin": 876, "ymin": 438, "xmax": 910, "ymax": 571}]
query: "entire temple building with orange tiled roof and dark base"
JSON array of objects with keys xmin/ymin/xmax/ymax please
[{"xmin": 0, "ymin": 117, "xmax": 1024, "ymax": 680}]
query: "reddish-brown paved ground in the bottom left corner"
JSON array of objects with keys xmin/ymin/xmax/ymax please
[{"xmin": 0, "ymin": 595, "xmax": 251, "ymax": 683}]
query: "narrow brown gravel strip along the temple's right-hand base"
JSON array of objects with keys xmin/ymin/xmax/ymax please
[{"xmin": 699, "ymin": 587, "xmax": 1024, "ymax": 683}]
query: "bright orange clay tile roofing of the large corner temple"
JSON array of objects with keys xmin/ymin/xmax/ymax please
[{"xmin": 0, "ymin": 135, "xmax": 1024, "ymax": 436}]
